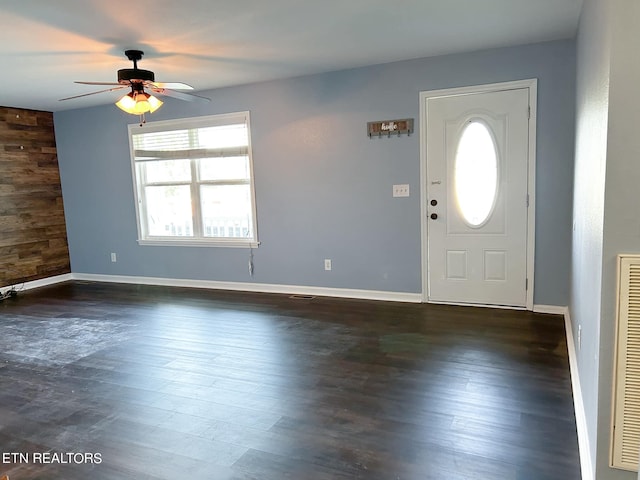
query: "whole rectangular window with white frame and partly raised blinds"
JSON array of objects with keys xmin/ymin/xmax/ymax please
[{"xmin": 129, "ymin": 112, "xmax": 258, "ymax": 246}]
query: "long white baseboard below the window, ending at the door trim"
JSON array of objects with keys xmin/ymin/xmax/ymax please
[{"xmin": 72, "ymin": 273, "xmax": 422, "ymax": 303}]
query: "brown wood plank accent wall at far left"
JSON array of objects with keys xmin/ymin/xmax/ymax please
[{"xmin": 0, "ymin": 107, "xmax": 71, "ymax": 287}]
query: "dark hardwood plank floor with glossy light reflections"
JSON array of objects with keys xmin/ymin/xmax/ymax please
[{"xmin": 0, "ymin": 282, "xmax": 580, "ymax": 480}]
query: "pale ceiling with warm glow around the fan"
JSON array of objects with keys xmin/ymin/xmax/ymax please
[{"xmin": 0, "ymin": 0, "xmax": 582, "ymax": 111}]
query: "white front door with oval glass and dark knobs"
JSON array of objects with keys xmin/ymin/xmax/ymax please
[{"xmin": 422, "ymin": 82, "xmax": 534, "ymax": 308}]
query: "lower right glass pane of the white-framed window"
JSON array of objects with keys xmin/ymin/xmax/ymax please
[{"xmin": 200, "ymin": 185, "xmax": 253, "ymax": 238}]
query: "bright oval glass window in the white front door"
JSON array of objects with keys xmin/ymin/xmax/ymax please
[{"xmin": 454, "ymin": 121, "xmax": 498, "ymax": 227}]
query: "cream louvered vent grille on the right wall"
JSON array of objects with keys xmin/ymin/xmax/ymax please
[{"xmin": 611, "ymin": 255, "xmax": 640, "ymax": 471}]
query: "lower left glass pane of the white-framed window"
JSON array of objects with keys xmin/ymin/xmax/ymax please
[{"xmin": 144, "ymin": 185, "xmax": 193, "ymax": 237}]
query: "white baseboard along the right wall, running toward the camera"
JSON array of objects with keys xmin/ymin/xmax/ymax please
[{"xmin": 564, "ymin": 307, "xmax": 595, "ymax": 480}]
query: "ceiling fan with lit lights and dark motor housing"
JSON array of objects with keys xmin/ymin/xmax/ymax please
[{"xmin": 60, "ymin": 50, "xmax": 211, "ymax": 121}]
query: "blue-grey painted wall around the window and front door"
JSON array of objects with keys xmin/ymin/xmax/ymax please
[{"xmin": 54, "ymin": 41, "xmax": 575, "ymax": 305}]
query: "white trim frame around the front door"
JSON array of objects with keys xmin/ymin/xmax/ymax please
[{"xmin": 420, "ymin": 78, "xmax": 538, "ymax": 310}]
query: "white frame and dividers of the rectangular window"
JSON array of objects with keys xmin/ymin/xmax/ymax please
[{"xmin": 129, "ymin": 111, "xmax": 260, "ymax": 248}]
